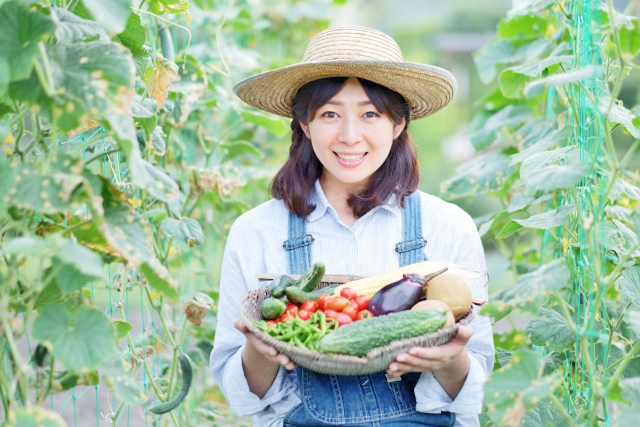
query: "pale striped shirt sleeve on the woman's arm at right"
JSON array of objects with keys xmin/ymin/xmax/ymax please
[{"xmin": 415, "ymin": 209, "xmax": 494, "ymax": 416}]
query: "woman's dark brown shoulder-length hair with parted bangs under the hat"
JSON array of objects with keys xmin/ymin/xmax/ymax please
[{"xmin": 271, "ymin": 77, "xmax": 420, "ymax": 218}]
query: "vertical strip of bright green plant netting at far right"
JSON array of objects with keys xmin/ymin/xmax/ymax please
[{"xmin": 563, "ymin": 0, "xmax": 610, "ymax": 425}]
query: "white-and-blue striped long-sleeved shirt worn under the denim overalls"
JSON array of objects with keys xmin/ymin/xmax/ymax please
[{"xmin": 211, "ymin": 181, "xmax": 494, "ymax": 427}]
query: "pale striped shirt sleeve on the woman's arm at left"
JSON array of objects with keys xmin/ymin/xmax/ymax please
[{"xmin": 210, "ymin": 224, "xmax": 300, "ymax": 418}]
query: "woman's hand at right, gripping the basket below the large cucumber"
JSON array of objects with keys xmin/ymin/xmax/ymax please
[{"xmin": 387, "ymin": 325, "xmax": 473, "ymax": 380}]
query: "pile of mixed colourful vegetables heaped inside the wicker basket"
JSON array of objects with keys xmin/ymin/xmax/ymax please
[{"xmin": 255, "ymin": 263, "xmax": 471, "ymax": 356}]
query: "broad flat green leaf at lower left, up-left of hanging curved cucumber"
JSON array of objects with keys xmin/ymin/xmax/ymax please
[{"xmin": 33, "ymin": 303, "xmax": 116, "ymax": 371}]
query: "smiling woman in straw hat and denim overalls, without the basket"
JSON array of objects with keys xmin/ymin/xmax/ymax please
[{"xmin": 211, "ymin": 27, "xmax": 493, "ymax": 426}]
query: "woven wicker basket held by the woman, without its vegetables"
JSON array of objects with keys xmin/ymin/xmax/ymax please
[{"xmin": 240, "ymin": 287, "xmax": 475, "ymax": 375}]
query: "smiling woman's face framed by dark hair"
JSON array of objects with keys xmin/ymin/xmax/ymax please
[{"xmin": 300, "ymin": 78, "xmax": 405, "ymax": 194}]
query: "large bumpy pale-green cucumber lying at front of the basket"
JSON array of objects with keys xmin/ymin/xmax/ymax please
[{"xmin": 318, "ymin": 310, "xmax": 447, "ymax": 356}]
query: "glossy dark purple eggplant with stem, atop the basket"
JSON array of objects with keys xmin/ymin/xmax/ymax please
[{"xmin": 369, "ymin": 267, "xmax": 448, "ymax": 316}]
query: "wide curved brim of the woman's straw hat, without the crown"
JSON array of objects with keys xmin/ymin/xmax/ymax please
[{"xmin": 233, "ymin": 61, "xmax": 457, "ymax": 120}]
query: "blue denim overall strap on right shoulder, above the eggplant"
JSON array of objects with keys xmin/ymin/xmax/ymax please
[{"xmin": 396, "ymin": 191, "xmax": 427, "ymax": 267}]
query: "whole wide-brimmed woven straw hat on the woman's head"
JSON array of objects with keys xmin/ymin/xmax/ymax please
[{"xmin": 233, "ymin": 26, "xmax": 456, "ymax": 120}]
